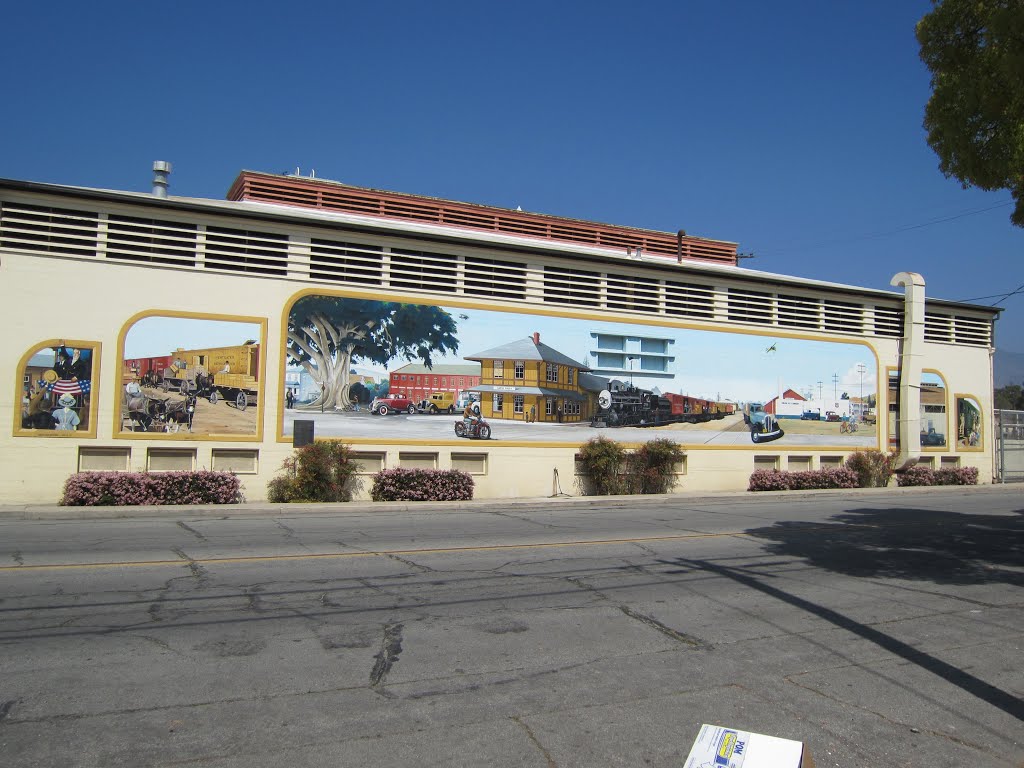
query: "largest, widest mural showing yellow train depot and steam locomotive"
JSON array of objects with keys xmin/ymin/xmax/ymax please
[{"xmin": 282, "ymin": 295, "xmax": 879, "ymax": 447}]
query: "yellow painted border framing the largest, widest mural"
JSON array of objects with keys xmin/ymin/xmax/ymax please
[{"xmin": 276, "ymin": 286, "xmax": 888, "ymax": 452}]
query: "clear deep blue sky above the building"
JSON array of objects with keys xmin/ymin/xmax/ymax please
[{"xmin": 0, "ymin": 0, "xmax": 1024, "ymax": 352}]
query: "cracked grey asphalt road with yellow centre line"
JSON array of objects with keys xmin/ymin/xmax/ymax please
[{"xmin": 0, "ymin": 487, "xmax": 1024, "ymax": 768}]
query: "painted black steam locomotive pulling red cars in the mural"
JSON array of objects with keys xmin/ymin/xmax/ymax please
[{"xmin": 593, "ymin": 385, "xmax": 736, "ymax": 427}]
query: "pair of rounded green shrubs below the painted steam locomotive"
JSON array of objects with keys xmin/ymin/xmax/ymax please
[{"xmin": 580, "ymin": 437, "xmax": 685, "ymax": 496}]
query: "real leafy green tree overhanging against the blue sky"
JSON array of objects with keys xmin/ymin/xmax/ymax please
[{"xmin": 918, "ymin": 0, "xmax": 1024, "ymax": 226}]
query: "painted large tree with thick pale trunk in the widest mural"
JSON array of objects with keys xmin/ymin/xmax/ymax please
[{"xmin": 287, "ymin": 296, "xmax": 459, "ymax": 411}]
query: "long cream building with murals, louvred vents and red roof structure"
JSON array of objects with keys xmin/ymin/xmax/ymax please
[{"xmin": 0, "ymin": 164, "xmax": 997, "ymax": 503}]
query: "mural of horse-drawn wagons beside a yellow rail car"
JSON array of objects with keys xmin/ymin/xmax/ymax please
[{"xmin": 119, "ymin": 315, "xmax": 262, "ymax": 435}]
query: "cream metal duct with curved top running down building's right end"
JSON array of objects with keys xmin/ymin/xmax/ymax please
[{"xmin": 890, "ymin": 272, "xmax": 925, "ymax": 469}]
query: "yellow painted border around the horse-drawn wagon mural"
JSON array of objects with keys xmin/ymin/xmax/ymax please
[{"xmin": 111, "ymin": 309, "xmax": 267, "ymax": 442}]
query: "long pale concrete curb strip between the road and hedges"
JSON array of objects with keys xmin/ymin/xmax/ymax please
[{"xmin": 0, "ymin": 484, "xmax": 1011, "ymax": 521}]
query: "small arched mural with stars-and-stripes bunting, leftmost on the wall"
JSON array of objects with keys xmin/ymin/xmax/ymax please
[{"xmin": 18, "ymin": 342, "xmax": 95, "ymax": 435}]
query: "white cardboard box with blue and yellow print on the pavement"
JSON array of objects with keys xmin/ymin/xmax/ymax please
[{"xmin": 683, "ymin": 723, "xmax": 814, "ymax": 768}]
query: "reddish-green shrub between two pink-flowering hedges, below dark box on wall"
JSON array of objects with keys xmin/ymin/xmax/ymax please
[{"xmin": 266, "ymin": 440, "xmax": 359, "ymax": 504}]
